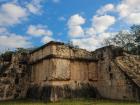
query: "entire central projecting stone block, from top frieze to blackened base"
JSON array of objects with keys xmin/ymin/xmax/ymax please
[{"xmin": 28, "ymin": 43, "xmax": 97, "ymax": 100}]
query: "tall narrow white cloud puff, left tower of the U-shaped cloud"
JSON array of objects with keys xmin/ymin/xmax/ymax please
[{"xmin": 68, "ymin": 14, "xmax": 85, "ymax": 37}]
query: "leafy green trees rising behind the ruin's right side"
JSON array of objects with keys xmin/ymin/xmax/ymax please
[{"xmin": 104, "ymin": 25, "xmax": 140, "ymax": 55}]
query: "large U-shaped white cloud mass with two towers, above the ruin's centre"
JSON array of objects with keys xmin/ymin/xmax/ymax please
[{"xmin": 68, "ymin": 14, "xmax": 116, "ymax": 51}]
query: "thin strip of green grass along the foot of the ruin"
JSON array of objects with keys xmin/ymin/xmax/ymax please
[{"xmin": 0, "ymin": 100, "xmax": 140, "ymax": 105}]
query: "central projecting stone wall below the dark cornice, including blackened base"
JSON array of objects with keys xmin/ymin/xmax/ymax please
[{"xmin": 27, "ymin": 58, "xmax": 97, "ymax": 101}]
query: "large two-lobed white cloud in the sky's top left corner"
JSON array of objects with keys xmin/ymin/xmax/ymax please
[{"xmin": 0, "ymin": 0, "xmax": 45, "ymax": 26}]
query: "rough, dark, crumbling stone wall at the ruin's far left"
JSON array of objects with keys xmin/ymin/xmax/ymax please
[{"xmin": 0, "ymin": 54, "xmax": 29, "ymax": 100}]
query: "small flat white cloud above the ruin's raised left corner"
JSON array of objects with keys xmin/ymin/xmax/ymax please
[{"xmin": 27, "ymin": 25, "xmax": 53, "ymax": 36}]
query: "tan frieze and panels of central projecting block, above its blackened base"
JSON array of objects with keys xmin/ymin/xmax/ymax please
[{"xmin": 30, "ymin": 43, "xmax": 97, "ymax": 83}]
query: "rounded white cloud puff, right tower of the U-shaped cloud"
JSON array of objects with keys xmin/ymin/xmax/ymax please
[{"xmin": 92, "ymin": 15, "xmax": 116, "ymax": 33}]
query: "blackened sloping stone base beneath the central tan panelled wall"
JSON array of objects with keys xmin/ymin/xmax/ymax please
[{"xmin": 27, "ymin": 83, "xmax": 97, "ymax": 101}]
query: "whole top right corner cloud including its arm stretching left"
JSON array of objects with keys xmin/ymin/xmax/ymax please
[{"xmin": 97, "ymin": 0, "xmax": 140, "ymax": 25}]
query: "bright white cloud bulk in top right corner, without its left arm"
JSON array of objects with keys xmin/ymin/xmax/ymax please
[{"xmin": 117, "ymin": 0, "xmax": 140, "ymax": 24}]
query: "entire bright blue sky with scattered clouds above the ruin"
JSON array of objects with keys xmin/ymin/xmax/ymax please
[{"xmin": 0, "ymin": 0, "xmax": 140, "ymax": 51}]
